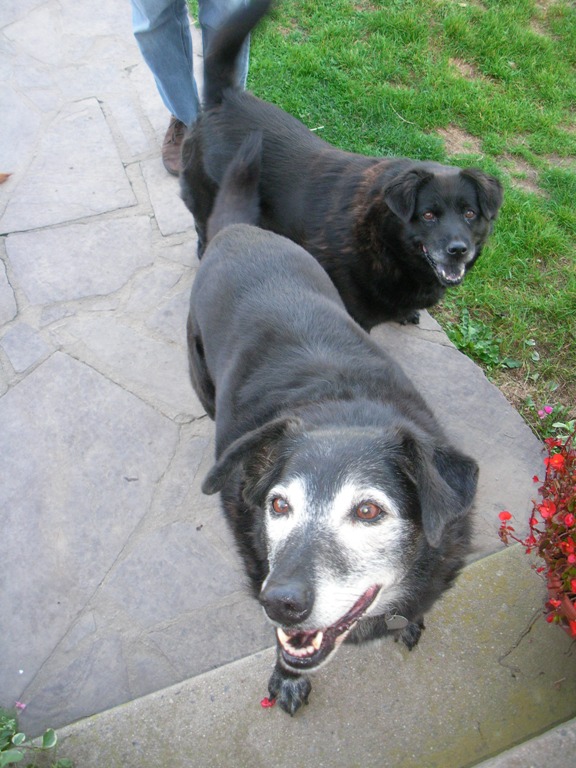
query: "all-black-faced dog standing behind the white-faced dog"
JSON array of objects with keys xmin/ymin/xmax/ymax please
[{"xmin": 181, "ymin": 0, "xmax": 502, "ymax": 330}]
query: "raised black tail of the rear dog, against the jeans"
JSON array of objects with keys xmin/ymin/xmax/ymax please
[{"xmin": 204, "ymin": 0, "xmax": 272, "ymax": 109}]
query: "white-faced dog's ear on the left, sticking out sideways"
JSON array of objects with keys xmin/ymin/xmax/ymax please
[{"xmin": 202, "ymin": 418, "xmax": 301, "ymax": 496}]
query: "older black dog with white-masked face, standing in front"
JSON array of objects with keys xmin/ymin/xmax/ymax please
[{"xmin": 188, "ymin": 133, "xmax": 478, "ymax": 714}]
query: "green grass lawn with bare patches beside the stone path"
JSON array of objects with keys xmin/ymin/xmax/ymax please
[{"xmin": 191, "ymin": 0, "xmax": 576, "ymax": 434}]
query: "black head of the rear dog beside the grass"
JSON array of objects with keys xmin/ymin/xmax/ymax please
[{"xmin": 383, "ymin": 163, "xmax": 503, "ymax": 287}]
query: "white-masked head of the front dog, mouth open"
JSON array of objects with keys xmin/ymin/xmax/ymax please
[{"xmin": 203, "ymin": 420, "xmax": 477, "ymax": 672}]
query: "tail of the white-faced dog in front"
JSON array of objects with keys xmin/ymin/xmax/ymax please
[{"xmin": 207, "ymin": 131, "xmax": 262, "ymax": 242}]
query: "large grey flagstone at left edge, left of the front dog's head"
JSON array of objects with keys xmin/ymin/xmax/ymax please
[{"xmin": 0, "ymin": 353, "xmax": 178, "ymax": 703}]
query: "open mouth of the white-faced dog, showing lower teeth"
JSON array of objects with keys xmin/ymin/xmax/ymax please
[{"xmin": 276, "ymin": 585, "xmax": 380, "ymax": 670}]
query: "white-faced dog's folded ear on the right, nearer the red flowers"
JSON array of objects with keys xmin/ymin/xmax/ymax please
[{"xmin": 404, "ymin": 436, "xmax": 478, "ymax": 547}]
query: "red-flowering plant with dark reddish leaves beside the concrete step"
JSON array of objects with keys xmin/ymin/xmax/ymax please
[{"xmin": 498, "ymin": 430, "xmax": 576, "ymax": 638}]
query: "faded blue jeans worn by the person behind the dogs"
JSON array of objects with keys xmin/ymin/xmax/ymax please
[{"xmin": 130, "ymin": 0, "xmax": 250, "ymax": 127}]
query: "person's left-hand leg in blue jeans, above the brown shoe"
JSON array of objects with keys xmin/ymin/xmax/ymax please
[{"xmin": 131, "ymin": 0, "xmax": 200, "ymax": 126}]
